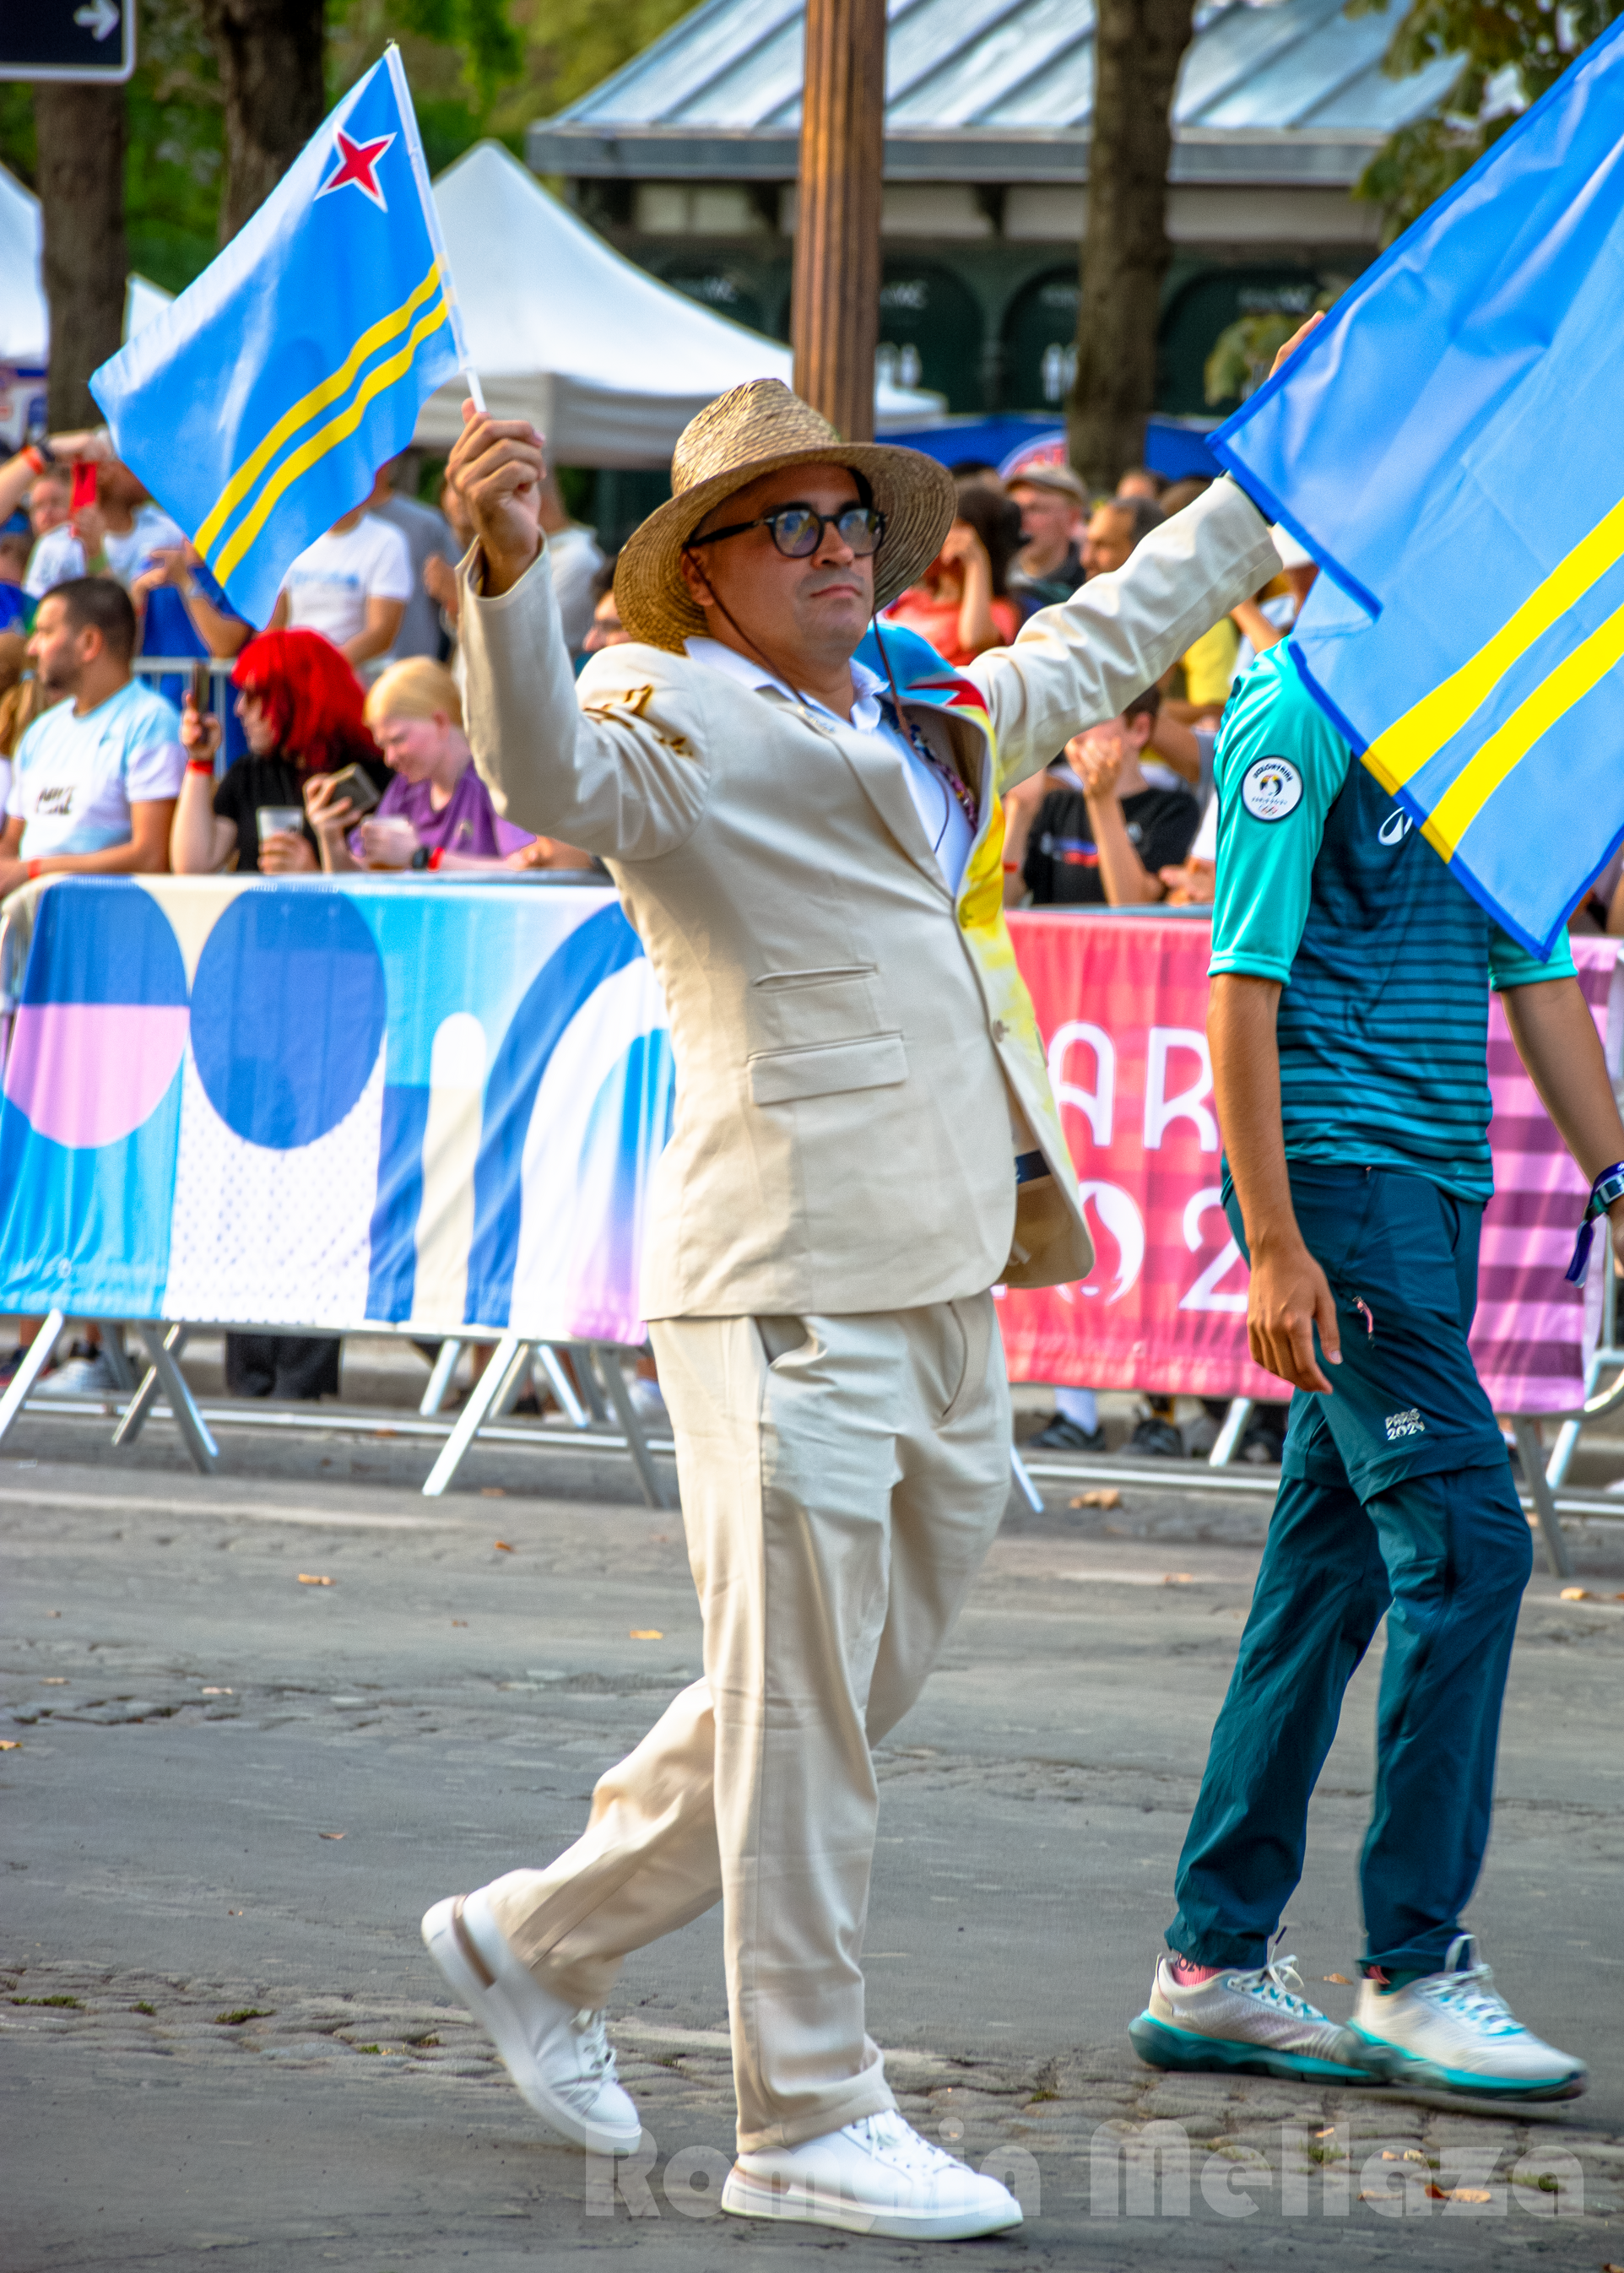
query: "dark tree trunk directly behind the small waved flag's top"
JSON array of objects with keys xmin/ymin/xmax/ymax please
[{"xmin": 205, "ymin": 0, "xmax": 328, "ymax": 243}]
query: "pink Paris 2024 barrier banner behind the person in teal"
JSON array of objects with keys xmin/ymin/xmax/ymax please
[{"xmin": 1001, "ymin": 909, "xmax": 1617, "ymax": 1414}]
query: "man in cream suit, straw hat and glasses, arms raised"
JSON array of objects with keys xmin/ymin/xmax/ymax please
[{"xmin": 423, "ymin": 380, "xmax": 1276, "ymax": 2239}]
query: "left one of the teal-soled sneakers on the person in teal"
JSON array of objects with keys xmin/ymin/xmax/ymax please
[{"xmin": 1129, "ymin": 1957, "xmax": 1388, "ymax": 2084}]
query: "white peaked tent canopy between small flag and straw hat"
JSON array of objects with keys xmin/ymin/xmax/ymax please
[{"xmin": 416, "ymin": 141, "xmax": 942, "ymax": 466}]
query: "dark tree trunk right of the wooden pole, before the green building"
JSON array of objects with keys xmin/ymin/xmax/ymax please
[{"xmin": 1067, "ymin": 0, "xmax": 1194, "ymax": 493}]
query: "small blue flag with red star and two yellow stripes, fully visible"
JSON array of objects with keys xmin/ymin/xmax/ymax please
[{"xmin": 91, "ymin": 48, "xmax": 468, "ymax": 625}]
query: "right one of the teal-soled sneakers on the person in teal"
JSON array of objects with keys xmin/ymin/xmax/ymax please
[{"xmin": 1353, "ymin": 1935, "xmax": 1588, "ymax": 2100}]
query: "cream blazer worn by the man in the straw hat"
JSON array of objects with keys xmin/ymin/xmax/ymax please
[{"xmin": 459, "ymin": 479, "xmax": 1278, "ymax": 1318}]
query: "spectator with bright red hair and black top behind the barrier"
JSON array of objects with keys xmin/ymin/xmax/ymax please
[{"xmin": 168, "ymin": 630, "xmax": 389, "ymax": 875}]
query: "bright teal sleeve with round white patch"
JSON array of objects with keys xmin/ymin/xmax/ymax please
[{"xmin": 1208, "ymin": 641, "xmax": 1351, "ymax": 987}]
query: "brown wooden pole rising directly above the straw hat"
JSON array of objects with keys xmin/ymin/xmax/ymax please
[{"xmin": 789, "ymin": 0, "xmax": 885, "ymax": 441}]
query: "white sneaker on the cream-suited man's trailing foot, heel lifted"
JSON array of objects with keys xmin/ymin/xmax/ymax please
[{"xmin": 423, "ymin": 1893, "xmax": 644, "ymax": 2155}]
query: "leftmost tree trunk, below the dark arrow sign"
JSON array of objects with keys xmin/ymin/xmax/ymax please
[{"xmin": 34, "ymin": 79, "xmax": 127, "ymax": 432}]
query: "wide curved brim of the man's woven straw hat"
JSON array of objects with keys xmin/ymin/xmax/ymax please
[{"xmin": 614, "ymin": 441, "xmax": 957, "ymax": 655}]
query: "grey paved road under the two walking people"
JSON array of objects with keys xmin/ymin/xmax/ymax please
[{"xmin": 0, "ymin": 1418, "xmax": 1624, "ymax": 2273}]
